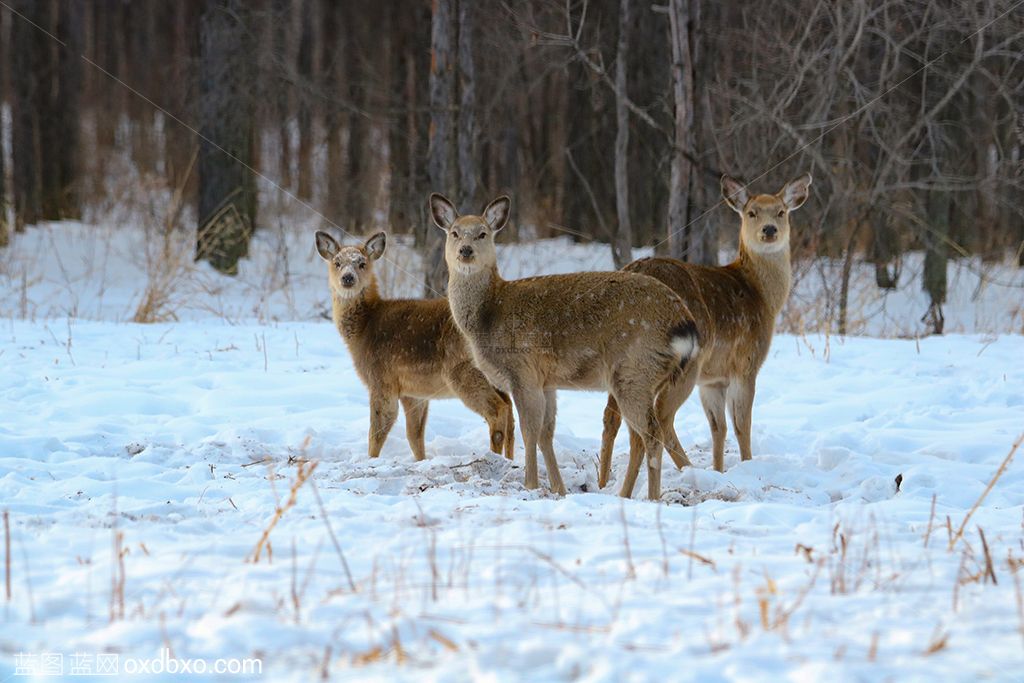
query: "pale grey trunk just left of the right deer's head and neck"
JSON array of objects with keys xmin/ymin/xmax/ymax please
[{"xmin": 668, "ymin": 0, "xmax": 703, "ymax": 262}]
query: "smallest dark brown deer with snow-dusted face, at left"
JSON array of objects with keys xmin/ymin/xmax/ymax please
[{"xmin": 316, "ymin": 231, "xmax": 515, "ymax": 460}]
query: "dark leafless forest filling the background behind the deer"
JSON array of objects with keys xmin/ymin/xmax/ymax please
[{"xmin": 3, "ymin": 0, "xmax": 1024, "ymax": 313}]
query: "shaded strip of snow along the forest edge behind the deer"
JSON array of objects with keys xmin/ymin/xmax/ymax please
[{"xmin": 0, "ymin": 219, "xmax": 1024, "ymax": 338}]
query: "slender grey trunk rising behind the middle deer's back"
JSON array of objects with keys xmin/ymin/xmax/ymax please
[{"xmin": 611, "ymin": 0, "xmax": 633, "ymax": 268}]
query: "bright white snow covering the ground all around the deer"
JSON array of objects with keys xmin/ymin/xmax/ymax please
[{"xmin": 0, "ymin": 225, "xmax": 1024, "ymax": 681}]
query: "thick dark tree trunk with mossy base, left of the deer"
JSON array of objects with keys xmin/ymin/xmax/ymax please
[{"xmin": 196, "ymin": 0, "xmax": 256, "ymax": 274}]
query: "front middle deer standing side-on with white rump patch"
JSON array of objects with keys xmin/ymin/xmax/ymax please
[{"xmin": 430, "ymin": 195, "xmax": 697, "ymax": 499}]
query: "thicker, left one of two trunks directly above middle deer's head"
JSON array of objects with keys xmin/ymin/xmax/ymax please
[{"xmin": 424, "ymin": 0, "xmax": 462, "ymax": 296}]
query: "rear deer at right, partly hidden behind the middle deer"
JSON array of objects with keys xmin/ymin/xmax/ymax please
[{"xmin": 598, "ymin": 174, "xmax": 811, "ymax": 493}]
